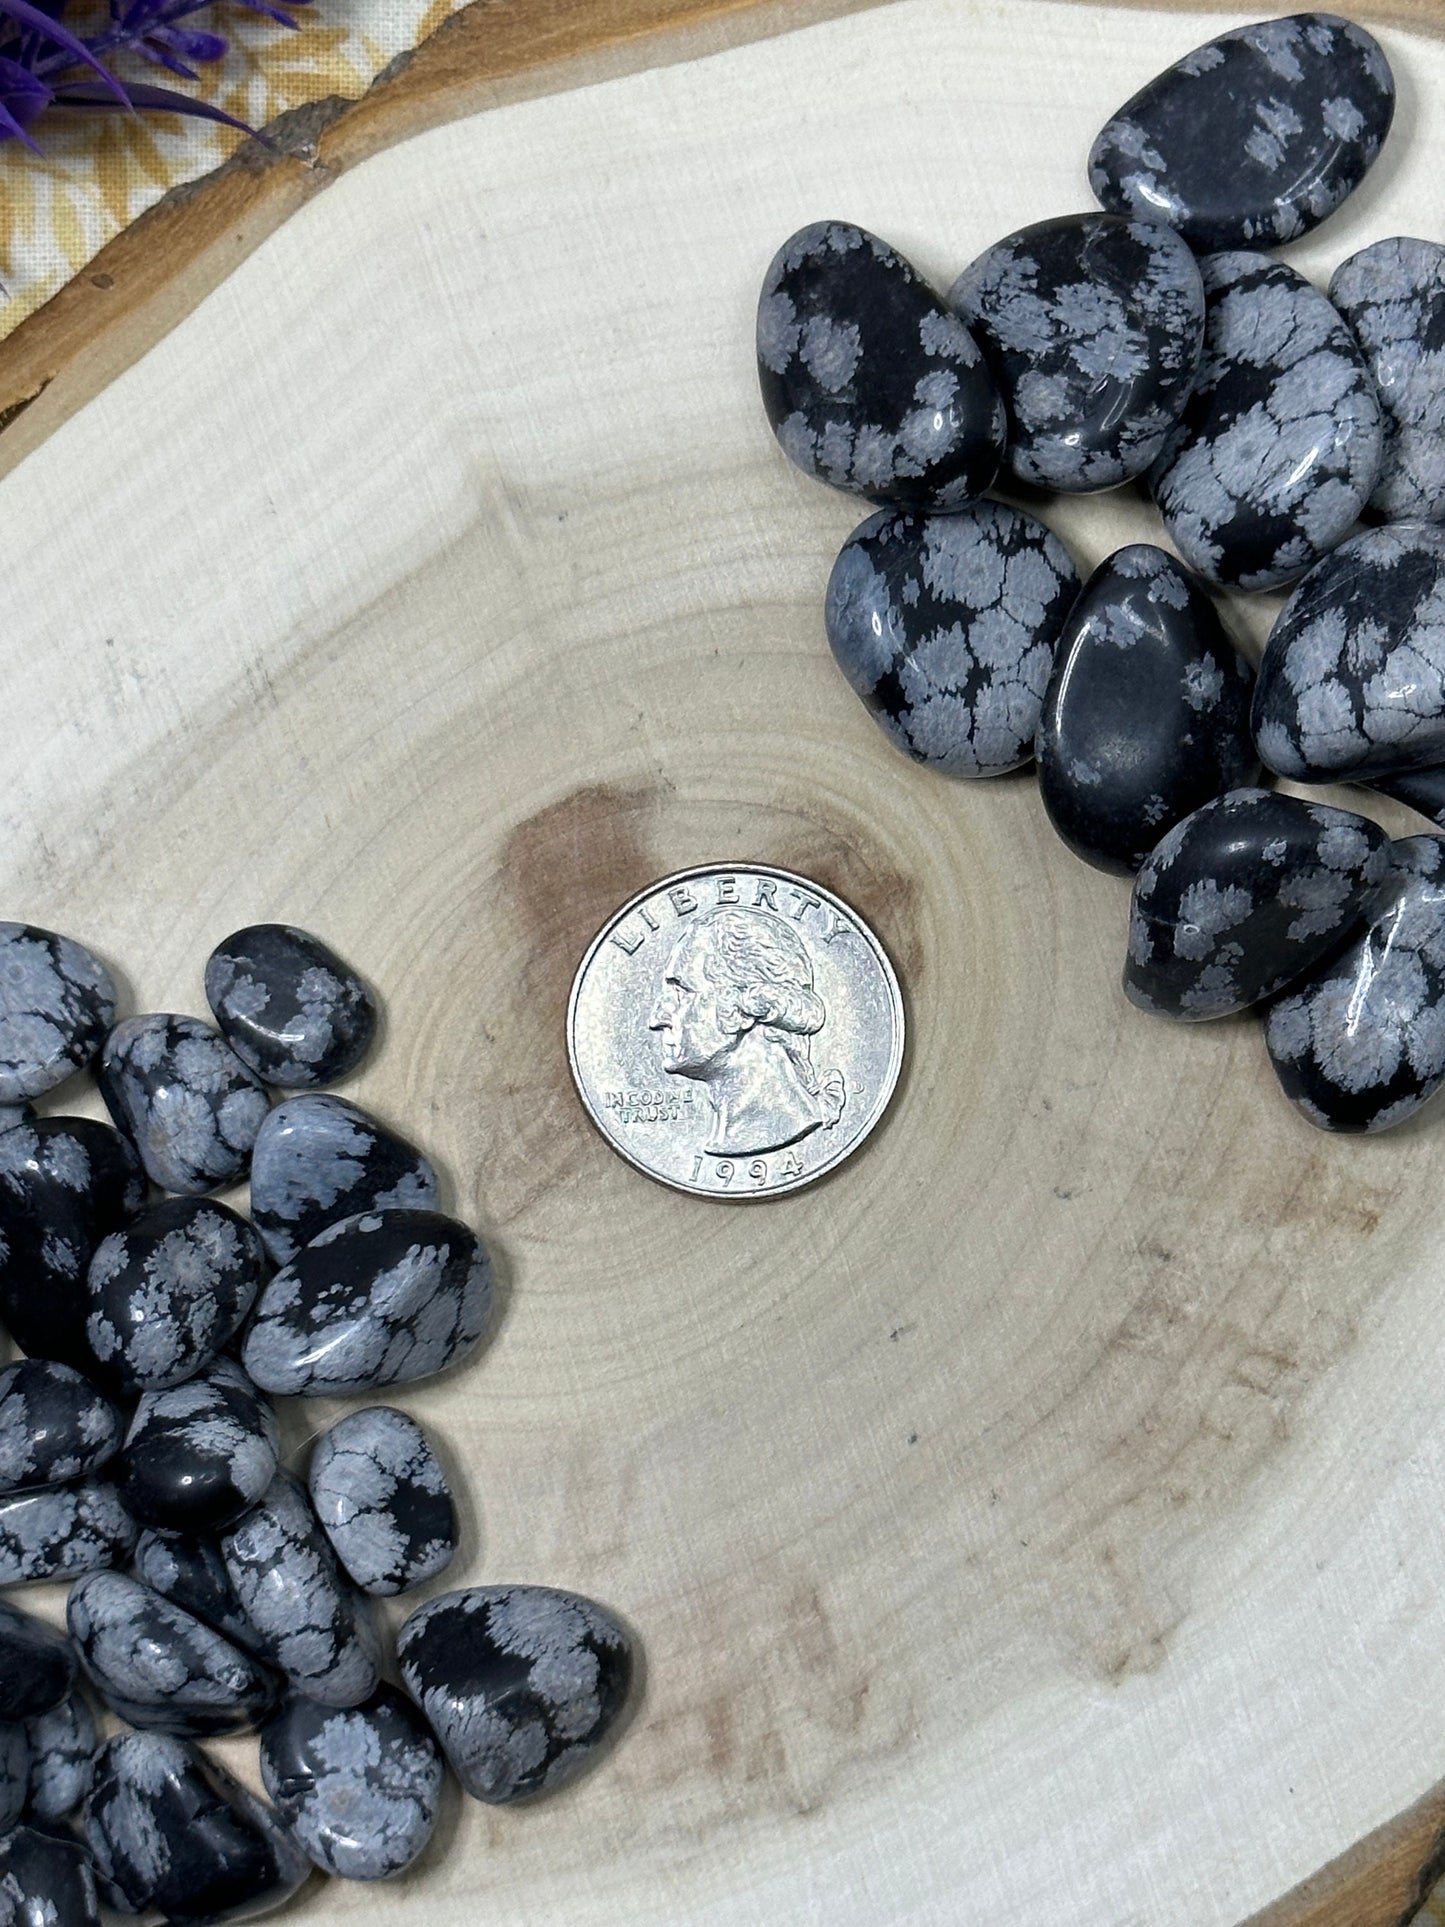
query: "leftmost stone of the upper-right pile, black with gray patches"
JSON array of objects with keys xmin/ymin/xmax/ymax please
[{"xmin": 757, "ymin": 222, "xmax": 1004, "ymax": 509}]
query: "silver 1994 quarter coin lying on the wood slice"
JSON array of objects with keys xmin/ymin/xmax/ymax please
[{"xmin": 566, "ymin": 863, "xmax": 904, "ymax": 1199}]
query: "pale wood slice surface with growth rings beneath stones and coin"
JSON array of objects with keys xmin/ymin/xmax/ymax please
[{"xmin": 0, "ymin": 0, "xmax": 1445, "ymax": 1927}]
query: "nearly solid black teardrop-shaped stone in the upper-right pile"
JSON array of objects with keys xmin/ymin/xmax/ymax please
[{"xmin": 1035, "ymin": 541, "xmax": 1260, "ymax": 877}]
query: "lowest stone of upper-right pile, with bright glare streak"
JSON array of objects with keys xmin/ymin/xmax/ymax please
[{"xmin": 1264, "ymin": 836, "xmax": 1445, "ymax": 1131}]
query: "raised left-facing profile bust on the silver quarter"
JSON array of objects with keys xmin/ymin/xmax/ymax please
[{"xmin": 647, "ymin": 904, "xmax": 848, "ymax": 1158}]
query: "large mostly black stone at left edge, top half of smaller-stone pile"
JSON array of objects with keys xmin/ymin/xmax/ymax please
[{"xmin": 0, "ymin": 1118, "xmax": 146, "ymax": 1372}]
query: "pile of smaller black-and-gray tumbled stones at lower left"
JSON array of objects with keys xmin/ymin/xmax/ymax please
[{"xmin": 0, "ymin": 923, "xmax": 632, "ymax": 1927}]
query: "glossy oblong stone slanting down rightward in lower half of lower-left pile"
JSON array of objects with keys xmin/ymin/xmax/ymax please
[{"xmin": 66, "ymin": 1572, "xmax": 281, "ymax": 1738}]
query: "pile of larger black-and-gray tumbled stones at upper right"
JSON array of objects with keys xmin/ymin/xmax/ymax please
[{"xmin": 757, "ymin": 13, "xmax": 1445, "ymax": 1131}]
